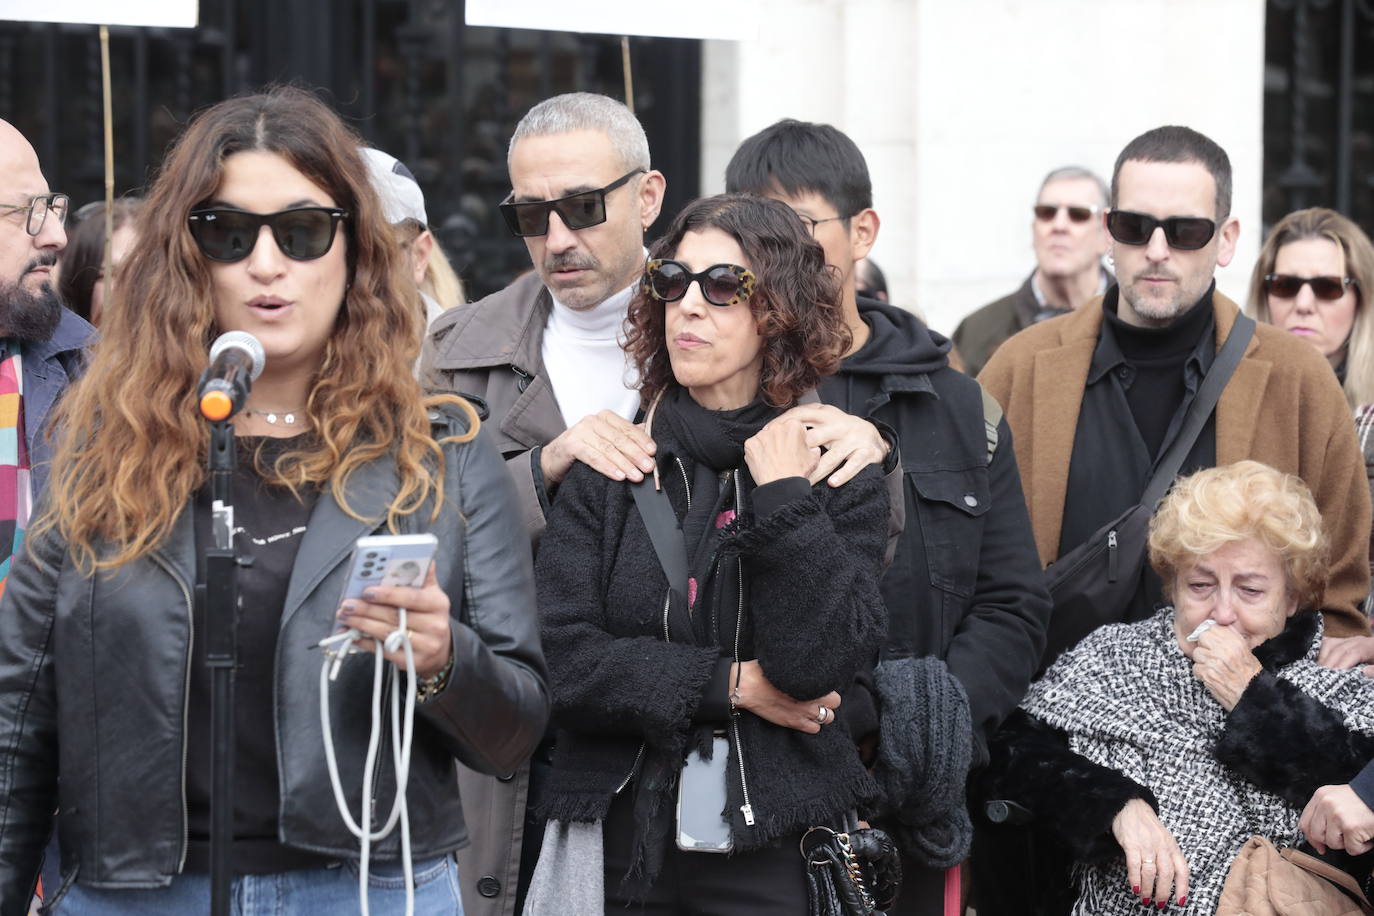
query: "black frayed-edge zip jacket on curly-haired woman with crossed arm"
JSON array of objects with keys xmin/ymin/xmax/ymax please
[{"xmin": 536, "ymin": 423, "xmax": 888, "ymax": 851}]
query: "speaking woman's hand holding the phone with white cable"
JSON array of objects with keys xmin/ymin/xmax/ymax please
[{"xmin": 338, "ymin": 563, "xmax": 453, "ymax": 678}]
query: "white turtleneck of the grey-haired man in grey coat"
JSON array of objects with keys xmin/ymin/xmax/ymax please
[{"xmin": 543, "ymin": 279, "xmax": 639, "ymax": 427}]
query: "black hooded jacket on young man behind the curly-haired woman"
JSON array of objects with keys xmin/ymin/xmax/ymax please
[{"xmin": 820, "ymin": 299, "xmax": 1050, "ymax": 766}]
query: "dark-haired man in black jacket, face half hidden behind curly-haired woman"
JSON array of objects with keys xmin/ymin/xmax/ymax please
[{"xmin": 725, "ymin": 119, "xmax": 1050, "ymax": 916}]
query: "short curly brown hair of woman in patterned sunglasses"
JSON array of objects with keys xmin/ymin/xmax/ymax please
[{"xmin": 625, "ymin": 194, "xmax": 853, "ymax": 407}]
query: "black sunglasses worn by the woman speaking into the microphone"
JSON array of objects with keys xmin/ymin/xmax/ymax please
[{"xmin": 187, "ymin": 207, "xmax": 349, "ymax": 264}]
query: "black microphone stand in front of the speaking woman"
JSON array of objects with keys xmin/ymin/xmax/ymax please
[{"xmin": 198, "ymin": 419, "xmax": 239, "ymax": 916}]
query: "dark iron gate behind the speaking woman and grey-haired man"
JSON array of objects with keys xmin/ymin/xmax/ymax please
[{"xmin": 0, "ymin": 0, "xmax": 701, "ymax": 297}]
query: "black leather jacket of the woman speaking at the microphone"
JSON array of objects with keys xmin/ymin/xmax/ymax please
[{"xmin": 0, "ymin": 413, "xmax": 550, "ymax": 915}]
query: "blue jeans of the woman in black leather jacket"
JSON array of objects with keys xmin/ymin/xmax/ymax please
[{"xmin": 52, "ymin": 856, "xmax": 463, "ymax": 916}]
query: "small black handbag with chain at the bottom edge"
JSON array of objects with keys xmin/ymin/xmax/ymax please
[{"xmin": 801, "ymin": 827, "xmax": 901, "ymax": 916}]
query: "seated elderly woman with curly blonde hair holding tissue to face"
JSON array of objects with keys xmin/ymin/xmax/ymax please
[{"xmin": 989, "ymin": 461, "xmax": 1374, "ymax": 915}]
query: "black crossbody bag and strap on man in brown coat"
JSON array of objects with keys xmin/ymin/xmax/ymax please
[{"xmin": 1037, "ymin": 314, "xmax": 1254, "ymax": 677}]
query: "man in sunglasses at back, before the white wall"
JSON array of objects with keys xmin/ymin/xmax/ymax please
[{"xmin": 954, "ymin": 165, "xmax": 1112, "ymax": 375}]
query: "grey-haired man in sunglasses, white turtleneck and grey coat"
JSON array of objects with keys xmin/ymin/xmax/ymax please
[{"xmin": 420, "ymin": 92, "xmax": 665, "ymax": 916}]
